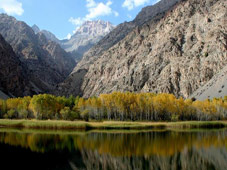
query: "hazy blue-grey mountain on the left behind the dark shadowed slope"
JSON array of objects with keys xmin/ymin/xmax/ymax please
[{"xmin": 0, "ymin": 14, "xmax": 75, "ymax": 93}]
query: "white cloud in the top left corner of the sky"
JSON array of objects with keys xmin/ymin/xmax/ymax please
[{"xmin": 0, "ymin": 0, "xmax": 24, "ymax": 15}]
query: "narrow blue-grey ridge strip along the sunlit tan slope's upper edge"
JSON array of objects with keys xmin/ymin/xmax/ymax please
[{"xmin": 74, "ymin": 0, "xmax": 181, "ymax": 71}]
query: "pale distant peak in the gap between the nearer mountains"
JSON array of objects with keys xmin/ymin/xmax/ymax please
[{"xmin": 61, "ymin": 20, "xmax": 115, "ymax": 60}]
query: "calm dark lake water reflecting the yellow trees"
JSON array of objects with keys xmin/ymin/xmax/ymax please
[{"xmin": 0, "ymin": 129, "xmax": 227, "ymax": 170}]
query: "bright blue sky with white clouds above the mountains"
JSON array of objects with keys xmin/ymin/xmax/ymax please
[{"xmin": 0, "ymin": 0, "xmax": 158, "ymax": 39}]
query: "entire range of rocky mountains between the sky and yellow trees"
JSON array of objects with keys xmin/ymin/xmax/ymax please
[{"xmin": 0, "ymin": 0, "xmax": 227, "ymax": 99}]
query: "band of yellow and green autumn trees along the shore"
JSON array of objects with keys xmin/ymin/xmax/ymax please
[{"xmin": 0, "ymin": 92, "xmax": 227, "ymax": 121}]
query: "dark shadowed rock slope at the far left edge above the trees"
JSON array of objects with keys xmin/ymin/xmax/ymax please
[{"xmin": 0, "ymin": 34, "xmax": 32, "ymax": 98}]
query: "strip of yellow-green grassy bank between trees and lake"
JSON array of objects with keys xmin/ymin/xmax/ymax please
[{"xmin": 0, "ymin": 119, "xmax": 227, "ymax": 130}]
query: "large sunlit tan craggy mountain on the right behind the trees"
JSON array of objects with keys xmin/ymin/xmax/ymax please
[{"xmin": 57, "ymin": 0, "xmax": 227, "ymax": 98}]
